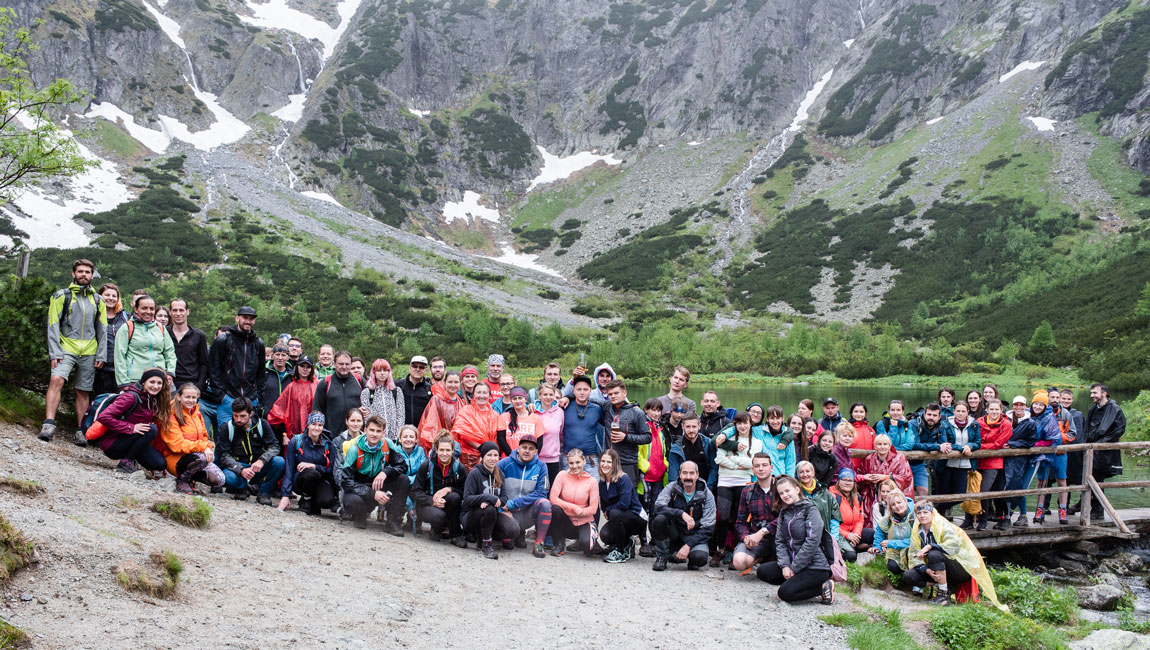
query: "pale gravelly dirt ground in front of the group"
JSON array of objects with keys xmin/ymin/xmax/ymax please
[{"xmin": 0, "ymin": 425, "xmax": 848, "ymax": 650}]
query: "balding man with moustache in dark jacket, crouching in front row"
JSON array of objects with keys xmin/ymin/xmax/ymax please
[{"xmin": 651, "ymin": 460, "xmax": 715, "ymax": 571}]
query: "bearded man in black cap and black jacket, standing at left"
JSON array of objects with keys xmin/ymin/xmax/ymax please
[{"xmin": 208, "ymin": 305, "xmax": 270, "ymax": 427}]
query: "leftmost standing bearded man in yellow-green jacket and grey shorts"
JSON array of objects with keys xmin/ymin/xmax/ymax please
[{"xmin": 40, "ymin": 259, "xmax": 108, "ymax": 441}]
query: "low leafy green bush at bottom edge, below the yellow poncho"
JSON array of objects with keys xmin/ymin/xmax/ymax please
[{"xmin": 930, "ymin": 603, "xmax": 1066, "ymax": 650}]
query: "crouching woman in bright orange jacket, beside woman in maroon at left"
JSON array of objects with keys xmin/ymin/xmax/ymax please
[{"xmin": 160, "ymin": 383, "xmax": 224, "ymax": 495}]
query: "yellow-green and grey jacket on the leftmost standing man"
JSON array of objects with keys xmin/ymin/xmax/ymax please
[{"xmin": 48, "ymin": 282, "xmax": 108, "ymax": 361}]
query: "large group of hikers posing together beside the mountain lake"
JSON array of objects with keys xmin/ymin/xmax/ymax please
[{"xmin": 39, "ymin": 259, "xmax": 1126, "ymax": 604}]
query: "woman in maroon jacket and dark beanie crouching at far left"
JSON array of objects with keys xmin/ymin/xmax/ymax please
[{"xmin": 87, "ymin": 368, "xmax": 171, "ymax": 474}]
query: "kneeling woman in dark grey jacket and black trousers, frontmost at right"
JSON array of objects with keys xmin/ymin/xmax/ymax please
[{"xmin": 758, "ymin": 476, "xmax": 835, "ymax": 605}]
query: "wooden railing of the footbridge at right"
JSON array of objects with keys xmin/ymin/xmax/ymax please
[{"xmin": 851, "ymin": 442, "xmax": 1150, "ymax": 535}]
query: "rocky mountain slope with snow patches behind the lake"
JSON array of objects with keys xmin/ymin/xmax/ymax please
[{"xmin": 6, "ymin": 0, "xmax": 1150, "ymax": 383}]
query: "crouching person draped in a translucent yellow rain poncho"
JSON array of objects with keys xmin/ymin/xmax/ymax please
[{"xmin": 903, "ymin": 503, "xmax": 1005, "ymax": 610}]
